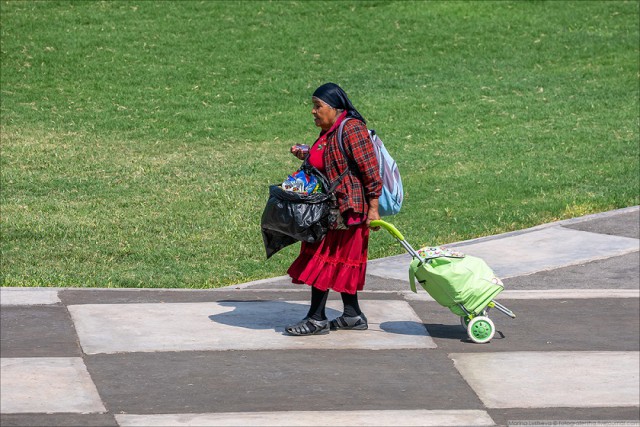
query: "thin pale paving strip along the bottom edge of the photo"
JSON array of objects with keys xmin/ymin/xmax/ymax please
[{"xmin": 116, "ymin": 410, "xmax": 495, "ymax": 427}]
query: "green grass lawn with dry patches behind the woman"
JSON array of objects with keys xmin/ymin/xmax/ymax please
[{"xmin": 0, "ymin": 1, "xmax": 640, "ymax": 288}]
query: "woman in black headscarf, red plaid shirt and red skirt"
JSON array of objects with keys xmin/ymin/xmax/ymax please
[{"xmin": 285, "ymin": 83, "xmax": 382, "ymax": 335}]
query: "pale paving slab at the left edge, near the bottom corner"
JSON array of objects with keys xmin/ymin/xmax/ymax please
[{"xmin": 0, "ymin": 357, "xmax": 106, "ymax": 414}]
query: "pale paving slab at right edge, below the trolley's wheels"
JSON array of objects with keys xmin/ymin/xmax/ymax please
[{"xmin": 450, "ymin": 351, "xmax": 640, "ymax": 408}]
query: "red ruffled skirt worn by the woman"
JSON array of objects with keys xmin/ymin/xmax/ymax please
[{"xmin": 287, "ymin": 224, "xmax": 369, "ymax": 294}]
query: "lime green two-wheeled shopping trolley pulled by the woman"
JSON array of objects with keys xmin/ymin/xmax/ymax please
[{"xmin": 371, "ymin": 220, "xmax": 516, "ymax": 343}]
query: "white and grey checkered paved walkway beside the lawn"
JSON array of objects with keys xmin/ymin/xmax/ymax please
[{"xmin": 0, "ymin": 207, "xmax": 640, "ymax": 426}]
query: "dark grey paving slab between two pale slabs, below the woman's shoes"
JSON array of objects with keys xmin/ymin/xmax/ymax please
[{"xmin": 86, "ymin": 349, "xmax": 484, "ymax": 415}]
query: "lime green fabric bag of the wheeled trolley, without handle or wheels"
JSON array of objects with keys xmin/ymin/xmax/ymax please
[{"xmin": 409, "ymin": 255, "xmax": 504, "ymax": 316}]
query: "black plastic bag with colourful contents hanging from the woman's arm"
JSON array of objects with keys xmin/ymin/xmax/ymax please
[{"xmin": 261, "ymin": 185, "xmax": 333, "ymax": 258}]
